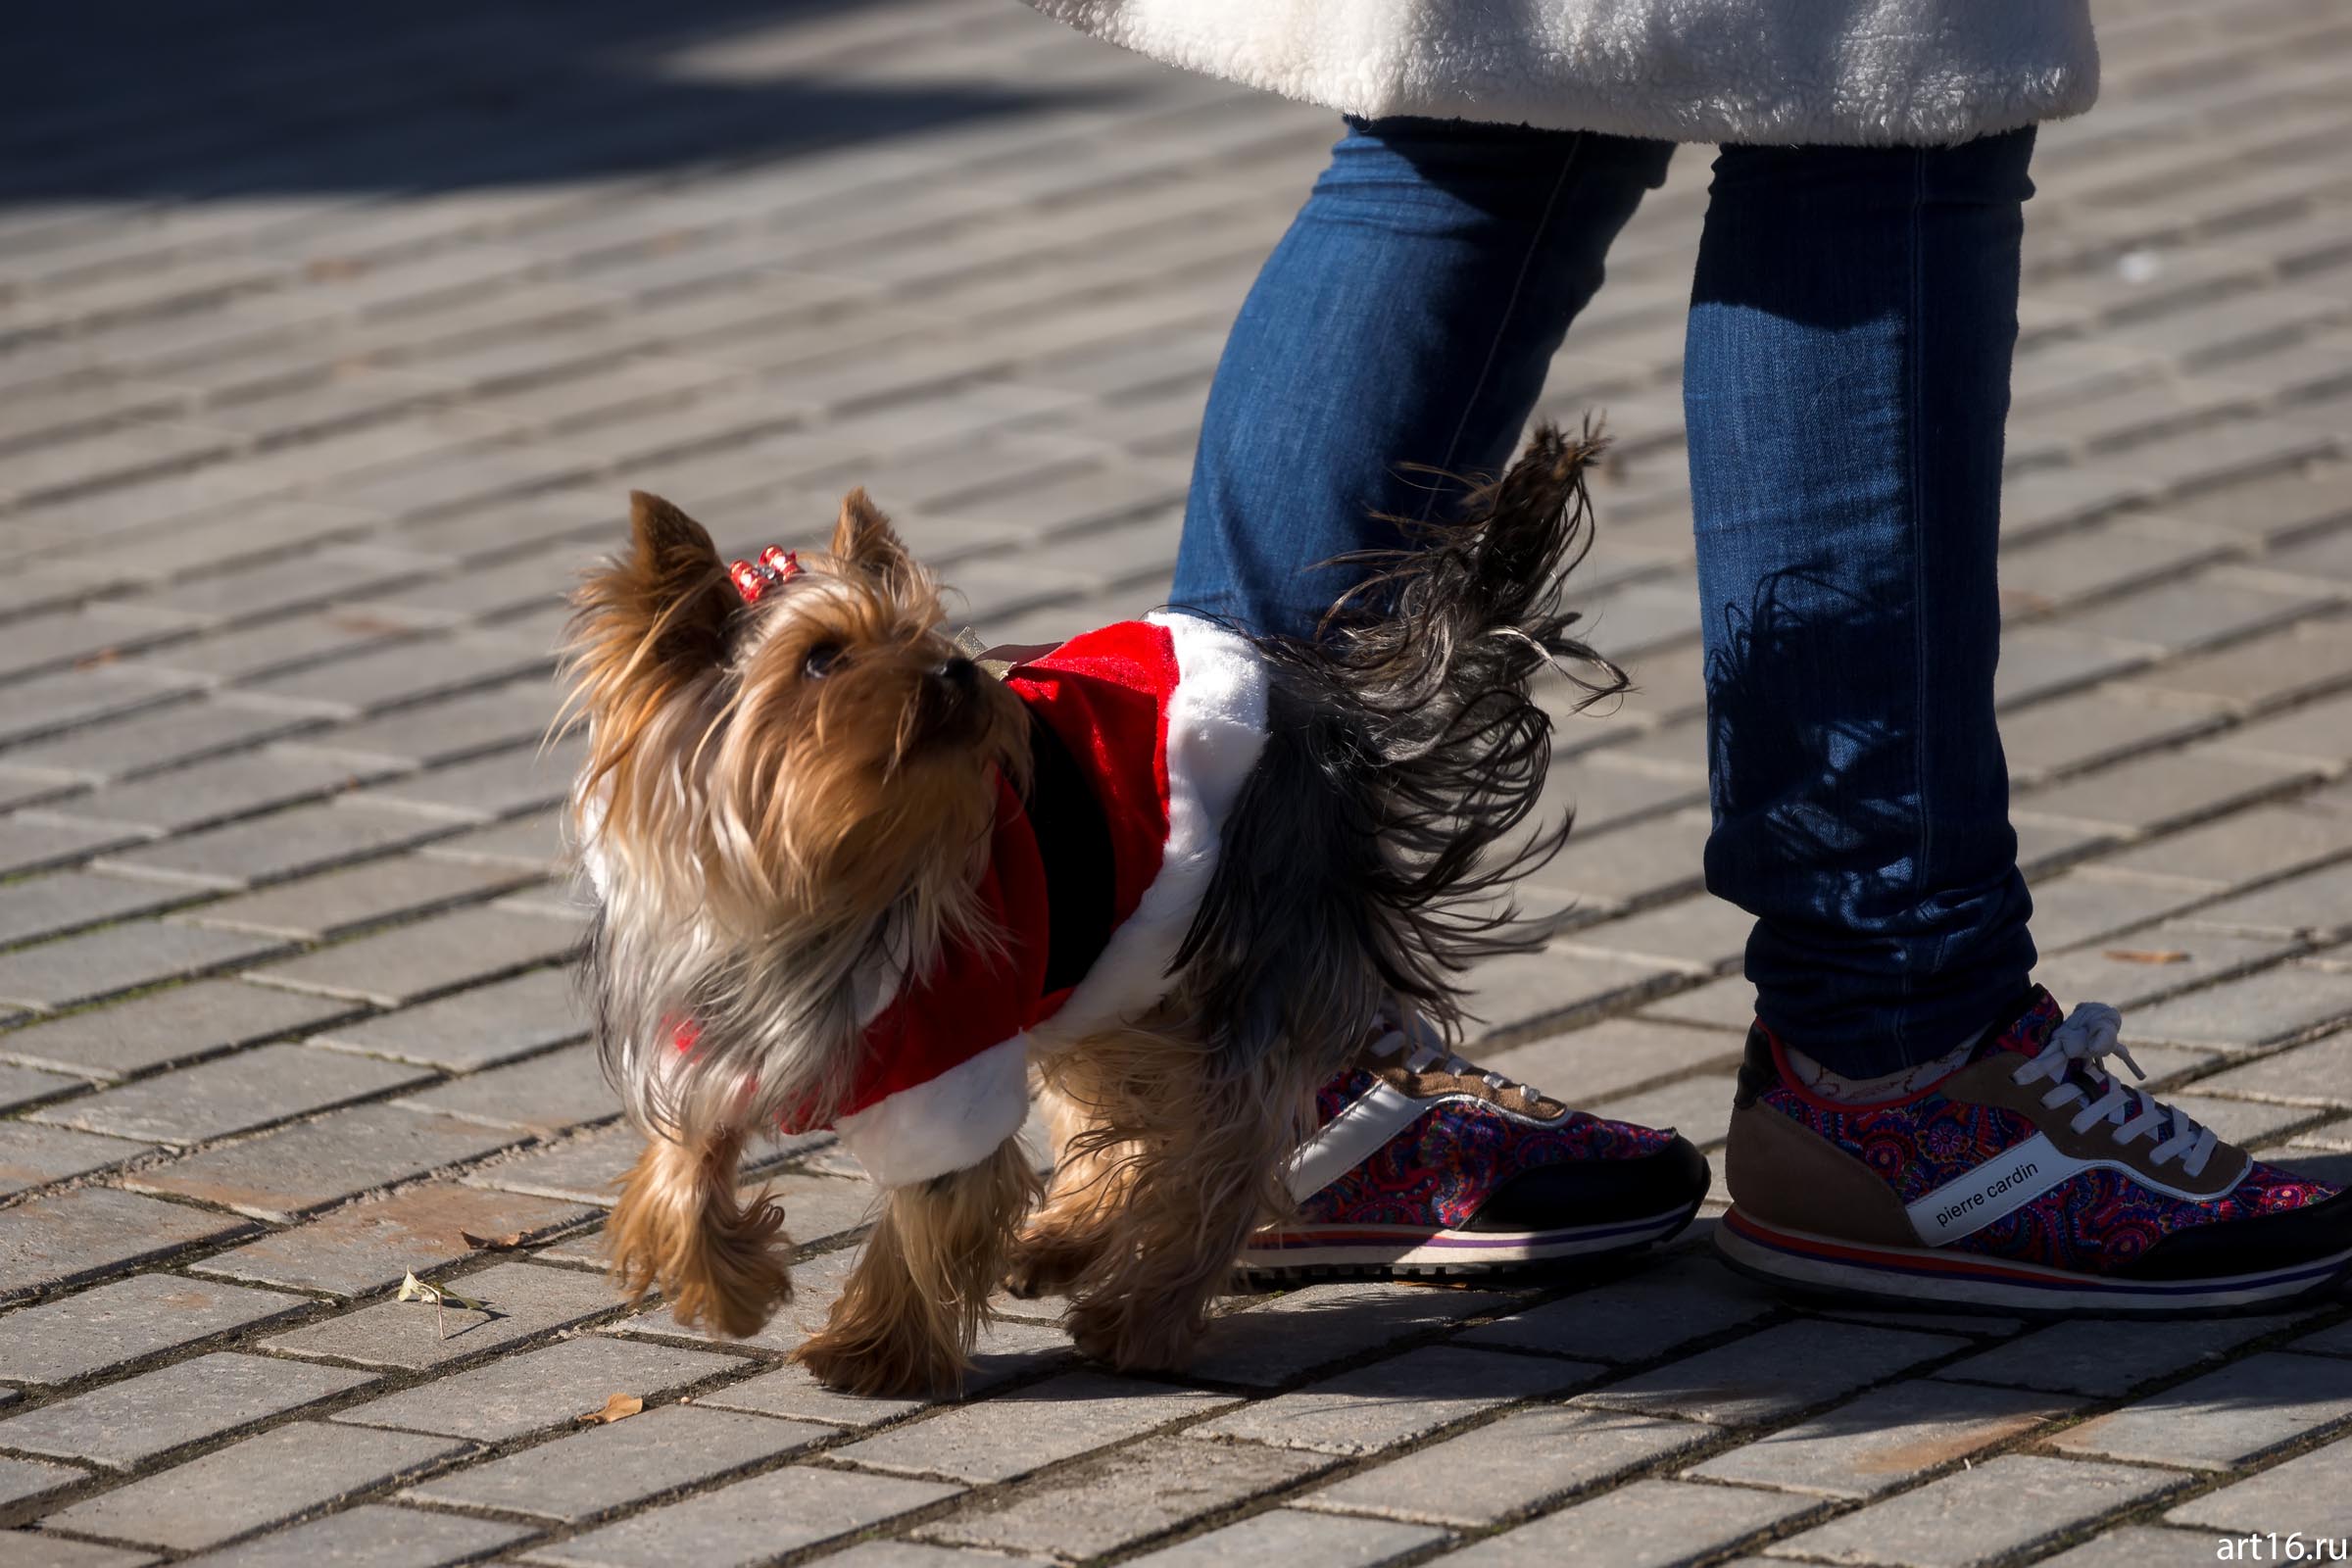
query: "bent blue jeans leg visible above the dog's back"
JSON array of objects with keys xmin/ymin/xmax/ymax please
[{"xmin": 1171, "ymin": 120, "xmax": 1672, "ymax": 637}]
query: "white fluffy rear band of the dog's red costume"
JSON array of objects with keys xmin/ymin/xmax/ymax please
[{"xmin": 1037, "ymin": 612, "xmax": 1265, "ymax": 1051}]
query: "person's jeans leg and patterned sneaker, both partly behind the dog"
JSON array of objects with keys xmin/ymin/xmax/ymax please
[{"xmin": 1171, "ymin": 120, "xmax": 1707, "ymax": 1277}]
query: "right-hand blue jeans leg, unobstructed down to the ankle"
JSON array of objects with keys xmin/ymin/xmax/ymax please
[{"xmin": 1684, "ymin": 129, "xmax": 2034, "ymax": 1077}]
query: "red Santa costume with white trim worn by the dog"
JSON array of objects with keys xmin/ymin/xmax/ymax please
[{"xmin": 835, "ymin": 613, "xmax": 1265, "ymax": 1187}]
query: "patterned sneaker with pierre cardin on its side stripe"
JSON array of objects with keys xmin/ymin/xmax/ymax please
[{"xmin": 1715, "ymin": 987, "xmax": 2352, "ymax": 1314}]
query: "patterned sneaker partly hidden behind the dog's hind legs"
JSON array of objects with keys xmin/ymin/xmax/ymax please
[{"xmin": 1242, "ymin": 1018, "xmax": 1707, "ymax": 1279}]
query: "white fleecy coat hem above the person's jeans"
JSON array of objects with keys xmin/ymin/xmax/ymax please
[{"xmin": 1030, "ymin": 0, "xmax": 2098, "ymax": 146}]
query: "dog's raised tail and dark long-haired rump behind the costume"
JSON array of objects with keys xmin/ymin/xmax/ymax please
[{"xmin": 1178, "ymin": 423, "xmax": 1625, "ymax": 1053}]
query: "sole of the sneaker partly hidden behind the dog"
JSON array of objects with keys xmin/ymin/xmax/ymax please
[{"xmin": 1237, "ymin": 1203, "xmax": 1698, "ymax": 1279}]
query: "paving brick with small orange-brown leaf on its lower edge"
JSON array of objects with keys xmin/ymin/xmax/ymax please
[{"xmin": 336, "ymin": 1336, "xmax": 746, "ymax": 1444}]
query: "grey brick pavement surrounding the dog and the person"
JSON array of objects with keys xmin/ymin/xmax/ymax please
[{"xmin": 0, "ymin": 0, "xmax": 2352, "ymax": 1568}]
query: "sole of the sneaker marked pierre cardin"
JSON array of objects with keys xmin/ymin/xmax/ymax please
[{"xmin": 1715, "ymin": 1206, "xmax": 2352, "ymax": 1316}]
